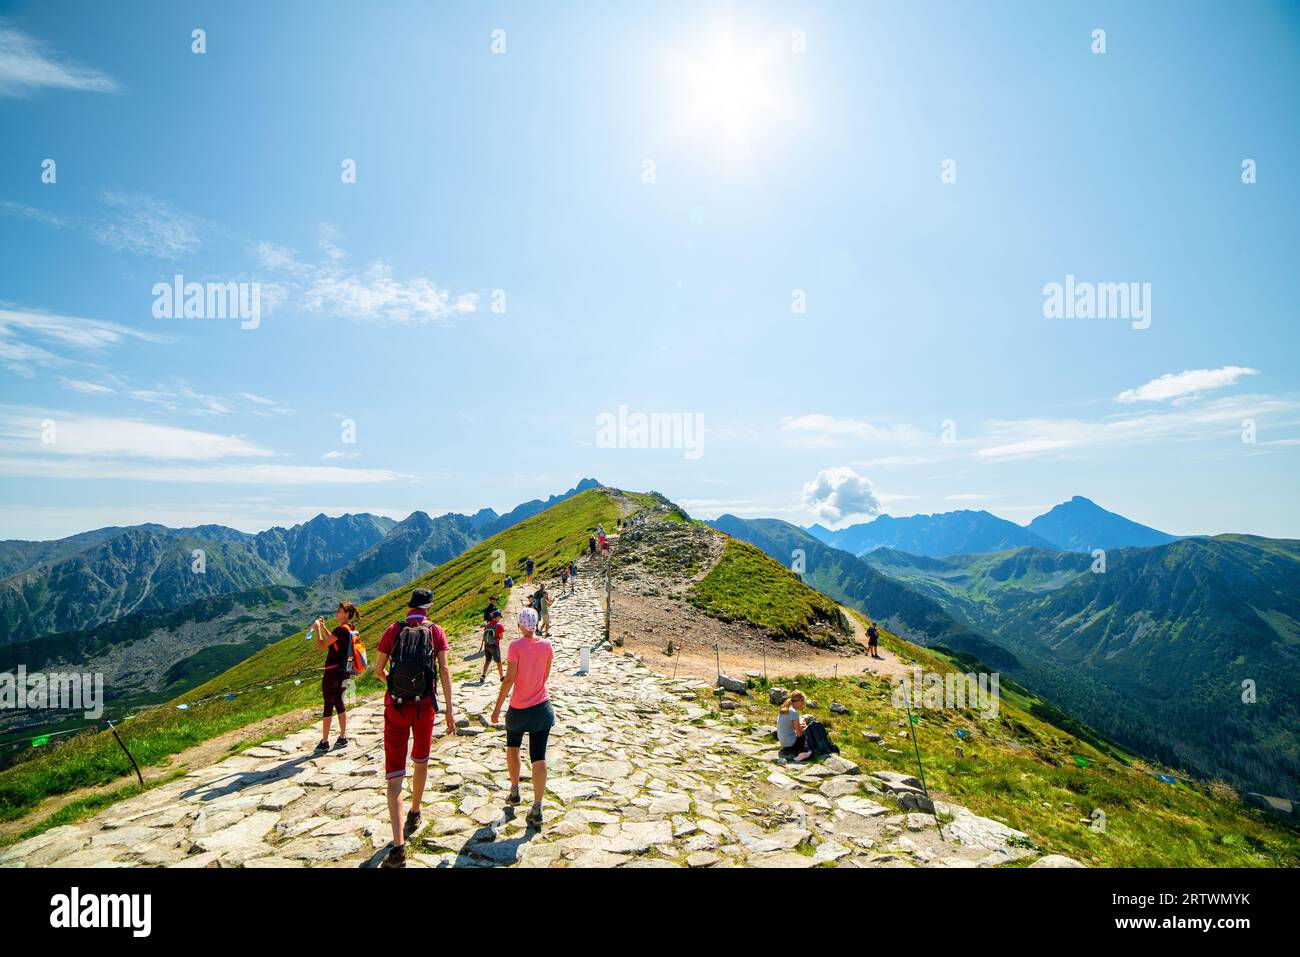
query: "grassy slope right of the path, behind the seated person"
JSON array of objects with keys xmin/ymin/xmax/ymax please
[{"xmin": 742, "ymin": 612, "xmax": 1300, "ymax": 867}]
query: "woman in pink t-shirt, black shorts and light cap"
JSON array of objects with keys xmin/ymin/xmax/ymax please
[{"xmin": 491, "ymin": 609, "xmax": 555, "ymax": 828}]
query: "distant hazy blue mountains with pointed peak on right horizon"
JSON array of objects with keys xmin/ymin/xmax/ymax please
[{"xmin": 807, "ymin": 495, "xmax": 1177, "ymax": 558}]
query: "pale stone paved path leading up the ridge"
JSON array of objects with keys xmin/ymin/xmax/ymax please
[{"xmin": 0, "ymin": 564, "xmax": 1036, "ymax": 867}]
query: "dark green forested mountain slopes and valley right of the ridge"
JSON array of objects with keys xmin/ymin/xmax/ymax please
[{"xmin": 711, "ymin": 512, "xmax": 1300, "ymax": 794}]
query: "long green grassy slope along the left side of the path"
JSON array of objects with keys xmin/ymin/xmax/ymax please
[{"xmin": 0, "ymin": 489, "xmax": 620, "ymax": 820}]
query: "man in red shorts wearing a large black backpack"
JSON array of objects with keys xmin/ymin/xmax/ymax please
[{"xmin": 374, "ymin": 588, "xmax": 456, "ymax": 867}]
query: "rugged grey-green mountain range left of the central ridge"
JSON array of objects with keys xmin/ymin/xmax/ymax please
[{"xmin": 0, "ymin": 479, "xmax": 599, "ymax": 644}]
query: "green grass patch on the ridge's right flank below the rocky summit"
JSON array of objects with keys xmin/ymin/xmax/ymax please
[{"xmin": 686, "ymin": 538, "xmax": 852, "ymax": 640}]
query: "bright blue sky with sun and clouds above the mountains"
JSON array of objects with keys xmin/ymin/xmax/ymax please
[{"xmin": 0, "ymin": 1, "xmax": 1300, "ymax": 538}]
